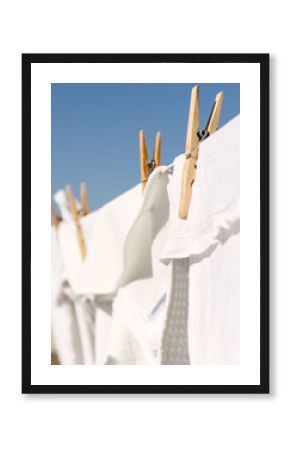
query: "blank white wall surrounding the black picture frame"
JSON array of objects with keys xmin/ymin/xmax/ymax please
[{"xmin": 0, "ymin": 0, "xmax": 290, "ymax": 450}]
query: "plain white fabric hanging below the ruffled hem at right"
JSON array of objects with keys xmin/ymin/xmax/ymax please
[{"xmin": 188, "ymin": 229, "xmax": 240, "ymax": 364}]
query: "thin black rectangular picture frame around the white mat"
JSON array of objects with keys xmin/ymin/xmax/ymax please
[{"xmin": 22, "ymin": 54, "xmax": 270, "ymax": 394}]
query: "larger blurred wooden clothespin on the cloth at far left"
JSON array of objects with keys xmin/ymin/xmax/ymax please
[{"xmin": 65, "ymin": 183, "xmax": 88, "ymax": 259}]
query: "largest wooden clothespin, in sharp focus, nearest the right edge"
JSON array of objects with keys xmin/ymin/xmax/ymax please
[{"xmin": 179, "ymin": 86, "xmax": 224, "ymax": 219}]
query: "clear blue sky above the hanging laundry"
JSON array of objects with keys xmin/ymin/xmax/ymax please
[{"xmin": 51, "ymin": 83, "xmax": 240, "ymax": 211}]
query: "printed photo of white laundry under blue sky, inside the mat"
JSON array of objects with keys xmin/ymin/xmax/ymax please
[{"xmin": 51, "ymin": 84, "xmax": 240, "ymax": 364}]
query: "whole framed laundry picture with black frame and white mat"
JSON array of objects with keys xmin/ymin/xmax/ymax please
[{"xmin": 22, "ymin": 54, "xmax": 269, "ymax": 393}]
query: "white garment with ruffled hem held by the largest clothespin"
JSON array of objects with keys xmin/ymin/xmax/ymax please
[{"xmin": 162, "ymin": 116, "xmax": 240, "ymax": 262}]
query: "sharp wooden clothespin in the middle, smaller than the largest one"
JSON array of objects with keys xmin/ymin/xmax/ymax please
[{"xmin": 139, "ymin": 130, "xmax": 161, "ymax": 194}]
